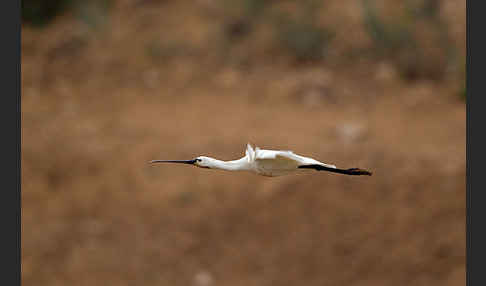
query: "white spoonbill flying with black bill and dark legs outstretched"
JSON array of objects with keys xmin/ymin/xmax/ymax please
[{"xmin": 150, "ymin": 144, "xmax": 372, "ymax": 177}]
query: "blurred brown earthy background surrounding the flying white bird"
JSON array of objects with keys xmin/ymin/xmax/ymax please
[{"xmin": 22, "ymin": 0, "xmax": 466, "ymax": 286}]
